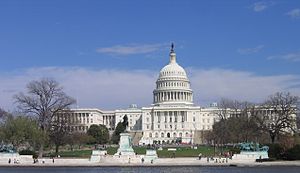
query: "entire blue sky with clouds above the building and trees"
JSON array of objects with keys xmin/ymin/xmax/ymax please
[{"xmin": 0, "ymin": 0, "xmax": 300, "ymax": 110}]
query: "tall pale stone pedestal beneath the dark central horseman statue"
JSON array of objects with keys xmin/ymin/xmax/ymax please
[{"xmin": 115, "ymin": 133, "xmax": 135, "ymax": 156}]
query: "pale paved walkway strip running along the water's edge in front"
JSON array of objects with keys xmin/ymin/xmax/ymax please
[{"xmin": 0, "ymin": 156, "xmax": 300, "ymax": 166}]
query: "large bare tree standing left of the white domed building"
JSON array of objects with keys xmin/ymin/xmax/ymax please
[{"xmin": 14, "ymin": 78, "xmax": 75, "ymax": 157}]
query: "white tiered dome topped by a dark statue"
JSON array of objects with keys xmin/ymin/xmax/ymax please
[{"xmin": 153, "ymin": 44, "xmax": 193, "ymax": 106}]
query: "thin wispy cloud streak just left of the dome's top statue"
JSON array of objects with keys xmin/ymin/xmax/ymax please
[{"xmin": 96, "ymin": 44, "xmax": 167, "ymax": 55}]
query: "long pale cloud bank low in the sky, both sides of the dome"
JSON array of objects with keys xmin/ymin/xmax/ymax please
[{"xmin": 0, "ymin": 67, "xmax": 300, "ymax": 110}]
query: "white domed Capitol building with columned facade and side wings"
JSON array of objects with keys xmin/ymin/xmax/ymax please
[{"xmin": 67, "ymin": 44, "xmax": 223, "ymax": 144}]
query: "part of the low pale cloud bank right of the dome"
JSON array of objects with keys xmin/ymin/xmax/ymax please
[{"xmin": 190, "ymin": 69, "xmax": 300, "ymax": 103}]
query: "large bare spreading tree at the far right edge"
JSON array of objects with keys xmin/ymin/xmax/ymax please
[{"xmin": 251, "ymin": 92, "xmax": 299, "ymax": 143}]
